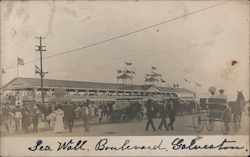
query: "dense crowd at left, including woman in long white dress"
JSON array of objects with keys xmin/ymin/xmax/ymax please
[{"xmin": 0, "ymin": 100, "xmax": 133, "ymax": 135}]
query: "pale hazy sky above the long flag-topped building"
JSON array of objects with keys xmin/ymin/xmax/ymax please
[{"xmin": 1, "ymin": 0, "xmax": 249, "ymax": 100}]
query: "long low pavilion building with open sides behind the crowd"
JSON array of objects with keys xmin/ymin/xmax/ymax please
[{"xmin": 3, "ymin": 77, "xmax": 195, "ymax": 102}]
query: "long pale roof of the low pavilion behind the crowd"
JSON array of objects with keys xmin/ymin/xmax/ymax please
[{"xmin": 3, "ymin": 77, "xmax": 191, "ymax": 92}]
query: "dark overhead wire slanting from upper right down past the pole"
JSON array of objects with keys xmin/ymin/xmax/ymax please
[{"xmin": 2, "ymin": 2, "xmax": 227, "ymax": 70}]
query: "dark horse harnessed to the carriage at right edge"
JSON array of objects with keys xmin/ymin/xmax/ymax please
[{"xmin": 228, "ymin": 91, "xmax": 245, "ymax": 125}]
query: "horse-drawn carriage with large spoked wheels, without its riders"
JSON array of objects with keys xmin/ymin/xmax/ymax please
[{"xmin": 193, "ymin": 97, "xmax": 240, "ymax": 134}]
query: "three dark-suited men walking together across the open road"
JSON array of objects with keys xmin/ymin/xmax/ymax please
[{"xmin": 145, "ymin": 98, "xmax": 176, "ymax": 131}]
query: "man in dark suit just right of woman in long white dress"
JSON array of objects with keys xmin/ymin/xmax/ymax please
[{"xmin": 64, "ymin": 102, "xmax": 76, "ymax": 132}]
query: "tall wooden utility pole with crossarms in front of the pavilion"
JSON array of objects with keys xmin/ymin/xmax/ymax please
[{"xmin": 35, "ymin": 36, "xmax": 47, "ymax": 105}]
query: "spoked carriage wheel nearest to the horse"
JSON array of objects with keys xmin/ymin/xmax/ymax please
[{"xmin": 221, "ymin": 109, "xmax": 232, "ymax": 135}]
